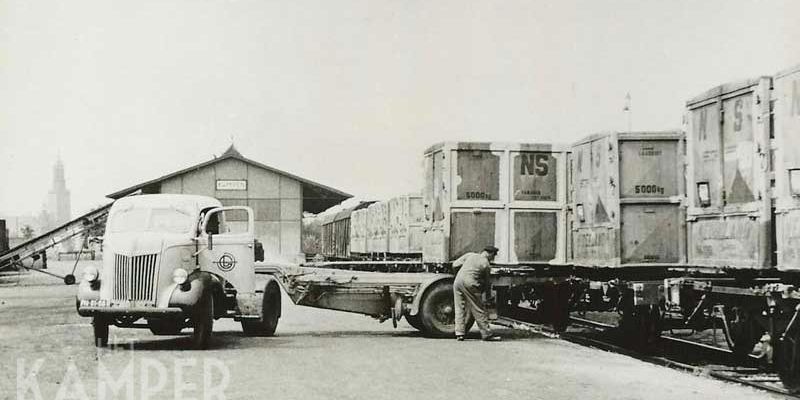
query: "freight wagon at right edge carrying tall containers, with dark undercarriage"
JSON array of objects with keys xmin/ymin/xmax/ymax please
[{"xmin": 665, "ymin": 63, "xmax": 800, "ymax": 390}]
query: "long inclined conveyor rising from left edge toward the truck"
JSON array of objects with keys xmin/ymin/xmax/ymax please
[{"xmin": 0, "ymin": 203, "xmax": 111, "ymax": 271}]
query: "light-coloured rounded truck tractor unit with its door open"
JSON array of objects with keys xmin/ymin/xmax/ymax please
[{"xmin": 77, "ymin": 194, "xmax": 280, "ymax": 349}]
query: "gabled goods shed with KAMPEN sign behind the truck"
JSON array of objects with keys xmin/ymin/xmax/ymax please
[{"xmin": 107, "ymin": 145, "xmax": 352, "ymax": 260}]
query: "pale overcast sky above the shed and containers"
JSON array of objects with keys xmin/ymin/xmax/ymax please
[{"xmin": 0, "ymin": 0, "xmax": 800, "ymax": 215}]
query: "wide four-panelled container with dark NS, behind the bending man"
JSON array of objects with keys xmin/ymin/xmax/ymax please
[{"xmin": 422, "ymin": 142, "xmax": 568, "ymax": 264}]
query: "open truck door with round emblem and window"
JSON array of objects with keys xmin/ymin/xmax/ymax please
[{"xmin": 198, "ymin": 206, "xmax": 255, "ymax": 292}]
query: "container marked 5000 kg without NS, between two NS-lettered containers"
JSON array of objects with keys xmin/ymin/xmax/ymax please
[{"xmin": 570, "ymin": 131, "xmax": 686, "ymax": 267}]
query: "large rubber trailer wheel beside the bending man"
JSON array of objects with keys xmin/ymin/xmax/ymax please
[{"xmin": 418, "ymin": 282, "xmax": 474, "ymax": 338}]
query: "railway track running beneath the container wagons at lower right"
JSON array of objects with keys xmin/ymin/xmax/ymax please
[{"xmin": 495, "ymin": 317, "xmax": 800, "ymax": 398}]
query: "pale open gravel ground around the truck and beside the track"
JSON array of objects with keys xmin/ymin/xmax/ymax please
[{"xmin": 0, "ymin": 261, "xmax": 780, "ymax": 400}]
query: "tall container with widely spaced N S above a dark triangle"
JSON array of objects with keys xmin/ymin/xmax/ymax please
[{"xmin": 686, "ymin": 77, "xmax": 776, "ymax": 269}]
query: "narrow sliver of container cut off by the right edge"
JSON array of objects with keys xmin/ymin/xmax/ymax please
[{"xmin": 770, "ymin": 65, "xmax": 800, "ymax": 271}]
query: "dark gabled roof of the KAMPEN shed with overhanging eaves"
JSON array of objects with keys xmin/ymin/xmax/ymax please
[{"xmin": 106, "ymin": 144, "xmax": 353, "ymax": 213}]
